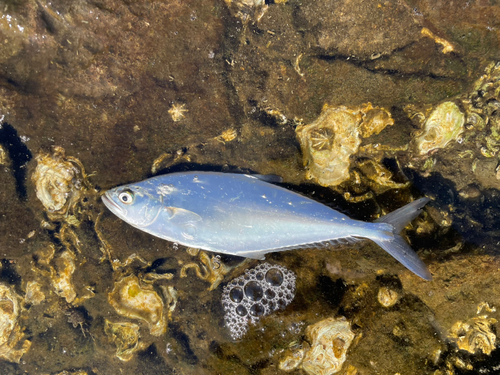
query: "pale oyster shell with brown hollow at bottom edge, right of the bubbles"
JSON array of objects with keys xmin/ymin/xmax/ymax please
[{"xmin": 302, "ymin": 317, "xmax": 355, "ymax": 375}]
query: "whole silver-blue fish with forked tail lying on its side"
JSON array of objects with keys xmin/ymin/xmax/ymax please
[{"xmin": 102, "ymin": 172, "xmax": 432, "ymax": 280}]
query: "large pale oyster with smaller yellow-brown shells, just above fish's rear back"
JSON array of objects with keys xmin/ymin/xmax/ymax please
[{"xmin": 296, "ymin": 103, "xmax": 407, "ymax": 201}]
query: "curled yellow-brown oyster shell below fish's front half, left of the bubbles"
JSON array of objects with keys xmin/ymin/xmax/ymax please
[{"xmin": 108, "ymin": 275, "xmax": 167, "ymax": 336}]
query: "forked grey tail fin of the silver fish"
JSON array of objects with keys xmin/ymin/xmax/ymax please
[{"xmin": 370, "ymin": 198, "xmax": 432, "ymax": 280}]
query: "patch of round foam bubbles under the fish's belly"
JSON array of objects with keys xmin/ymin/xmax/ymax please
[{"xmin": 222, "ymin": 263, "xmax": 296, "ymax": 340}]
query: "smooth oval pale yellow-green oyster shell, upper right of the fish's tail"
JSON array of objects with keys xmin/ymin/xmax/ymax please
[{"xmin": 415, "ymin": 102, "xmax": 465, "ymax": 155}]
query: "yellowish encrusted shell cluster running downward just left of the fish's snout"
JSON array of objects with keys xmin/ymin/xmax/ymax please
[{"xmin": 31, "ymin": 147, "xmax": 96, "ymax": 303}]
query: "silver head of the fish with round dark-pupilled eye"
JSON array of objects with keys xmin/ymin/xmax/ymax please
[{"xmin": 101, "ymin": 184, "xmax": 163, "ymax": 228}]
